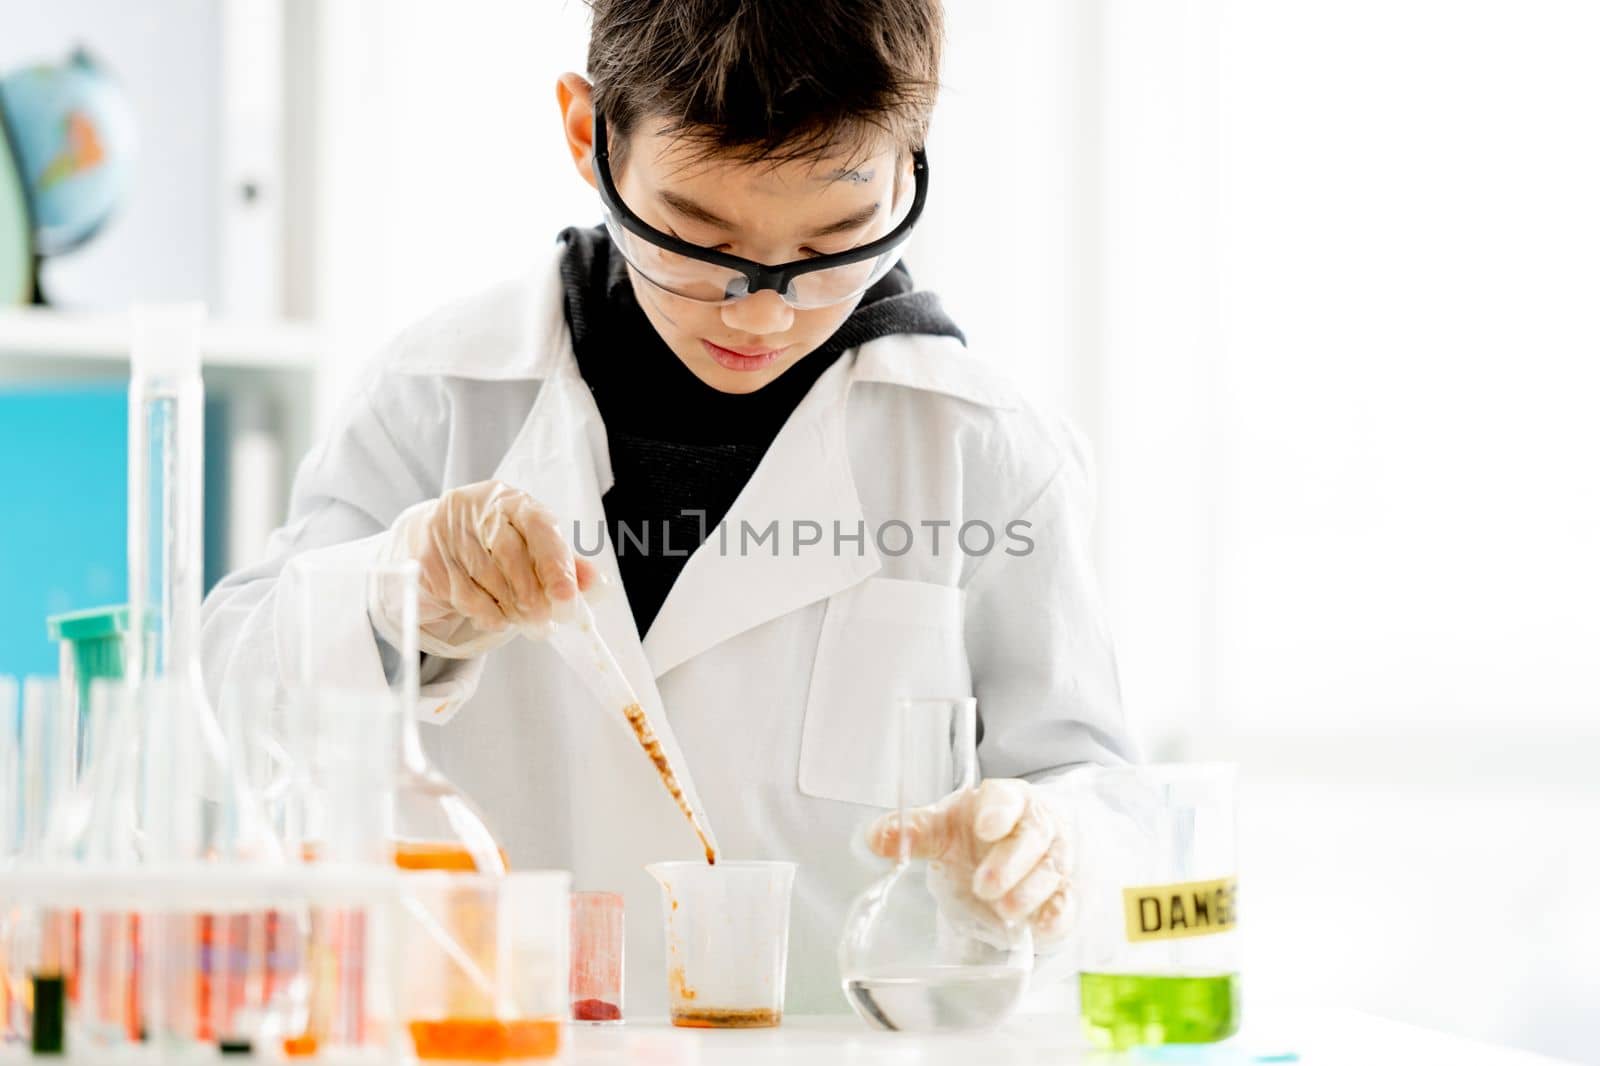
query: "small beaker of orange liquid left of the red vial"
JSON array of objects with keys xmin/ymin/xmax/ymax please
[{"xmin": 395, "ymin": 871, "xmax": 571, "ymax": 1063}]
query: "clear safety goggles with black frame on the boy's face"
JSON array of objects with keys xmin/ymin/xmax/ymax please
[{"xmin": 595, "ymin": 112, "xmax": 928, "ymax": 311}]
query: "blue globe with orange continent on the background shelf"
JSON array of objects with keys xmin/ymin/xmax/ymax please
[{"xmin": 0, "ymin": 48, "xmax": 134, "ymax": 256}]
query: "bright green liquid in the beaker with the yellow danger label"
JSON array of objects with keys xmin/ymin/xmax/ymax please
[{"xmin": 1078, "ymin": 973, "xmax": 1238, "ymax": 1052}]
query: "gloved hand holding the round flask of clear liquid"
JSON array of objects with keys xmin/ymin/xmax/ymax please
[{"xmin": 867, "ymin": 779, "xmax": 1069, "ymax": 949}]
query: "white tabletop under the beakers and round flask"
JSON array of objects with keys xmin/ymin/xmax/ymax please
[{"xmin": 566, "ymin": 1010, "xmax": 1557, "ymax": 1066}]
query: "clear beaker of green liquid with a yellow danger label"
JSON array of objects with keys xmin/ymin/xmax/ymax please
[{"xmin": 1072, "ymin": 763, "xmax": 1240, "ymax": 1050}]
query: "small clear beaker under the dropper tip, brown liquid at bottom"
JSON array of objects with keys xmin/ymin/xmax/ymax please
[{"xmin": 645, "ymin": 861, "xmax": 795, "ymax": 1029}]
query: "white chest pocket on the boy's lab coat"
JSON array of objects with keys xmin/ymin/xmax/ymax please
[{"xmin": 798, "ymin": 578, "xmax": 973, "ymax": 807}]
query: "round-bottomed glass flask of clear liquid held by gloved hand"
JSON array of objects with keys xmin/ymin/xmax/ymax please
[{"xmin": 838, "ymin": 699, "xmax": 1034, "ymax": 1031}]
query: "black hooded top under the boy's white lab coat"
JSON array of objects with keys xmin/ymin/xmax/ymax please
[{"xmin": 562, "ymin": 227, "xmax": 962, "ymax": 634}]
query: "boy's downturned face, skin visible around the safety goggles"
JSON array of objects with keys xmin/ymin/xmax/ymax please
[{"xmin": 563, "ymin": 75, "xmax": 912, "ymax": 392}]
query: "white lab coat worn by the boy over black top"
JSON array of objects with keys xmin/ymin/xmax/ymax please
[{"xmin": 203, "ymin": 243, "xmax": 1130, "ymax": 1012}]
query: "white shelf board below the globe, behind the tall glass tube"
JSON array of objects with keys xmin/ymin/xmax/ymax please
[{"xmin": 0, "ymin": 307, "xmax": 328, "ymax": 371}]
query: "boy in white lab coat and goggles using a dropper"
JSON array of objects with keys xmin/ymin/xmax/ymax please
[{"xmin": 205, "ymin": 0, "xmax": 1128, "ymax": 1012}]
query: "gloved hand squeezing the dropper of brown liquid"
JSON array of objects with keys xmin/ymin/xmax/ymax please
[{"xmin": 370, "ymin": 482, "xmax": 598, "ymax": 658}]
